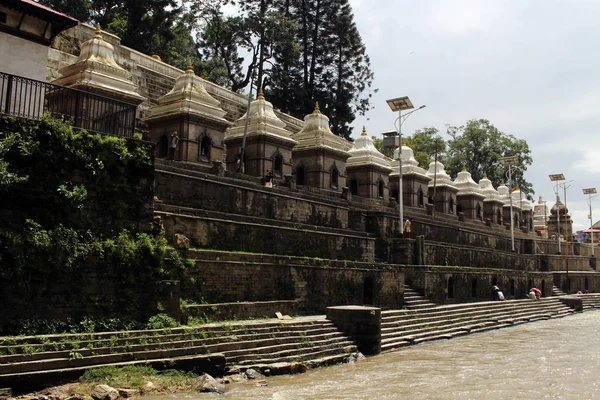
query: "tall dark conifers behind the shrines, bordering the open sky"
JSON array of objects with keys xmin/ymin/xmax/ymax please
[{"xmin": 266, "ymin": 0, "xmax": 373, "ymax": 138}]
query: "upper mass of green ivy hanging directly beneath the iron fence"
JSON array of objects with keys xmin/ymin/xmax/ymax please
[{"xmin": 0, "ymin": 116, "xmax": 152, "ymax": 234}]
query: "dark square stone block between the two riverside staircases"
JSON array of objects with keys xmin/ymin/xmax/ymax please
[{"xmin": 327, "ymin": 306, "xmax": 381, "ymax": 356}]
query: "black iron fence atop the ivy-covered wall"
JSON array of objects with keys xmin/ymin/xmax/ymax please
[{"xmin": 0, "ymin": 72, "xmax": 137, "ymax": 138}]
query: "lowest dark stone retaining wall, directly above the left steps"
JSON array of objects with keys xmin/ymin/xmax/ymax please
[{"xmin": 181, "ymin": 251, "xmax": 404, "ymax": 313}]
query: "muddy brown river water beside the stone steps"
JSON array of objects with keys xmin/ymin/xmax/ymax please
[{"xmin": 154, "ymin": 311, "xmax": 600, "ymax": 400}]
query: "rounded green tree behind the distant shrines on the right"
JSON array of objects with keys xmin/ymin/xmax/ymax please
[{"xmin": 444, "ymin": 119, "xmax": 535, "ymax": 200}]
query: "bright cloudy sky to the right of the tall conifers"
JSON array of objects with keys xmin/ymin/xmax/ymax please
[{"xmin": 350, "ymin": 0, "xmax": 600, "ymax": 230}]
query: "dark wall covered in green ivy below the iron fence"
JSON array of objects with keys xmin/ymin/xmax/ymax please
[{"xmin": 0, "ymin": 116, "xmax": 187, "ymax": 334}]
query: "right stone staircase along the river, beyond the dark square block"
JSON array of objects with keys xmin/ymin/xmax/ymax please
[{"xmin": 381, "ymin": 297, "xmax": 574, "ymax": 352}]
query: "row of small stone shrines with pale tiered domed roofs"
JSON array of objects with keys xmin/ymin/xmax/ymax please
[{"xmin": 48, "ymin": 27, "xmax": 556, "ymax": 230}]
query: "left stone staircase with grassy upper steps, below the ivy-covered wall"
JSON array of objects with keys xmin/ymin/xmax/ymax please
[{"xmin": 0, "ymin": 317, "xmax": 356, "ymax": 388}]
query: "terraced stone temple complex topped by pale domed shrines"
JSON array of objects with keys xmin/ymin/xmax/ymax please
[{"xmin": 0, "ymin": 1, "xmax": 600, "ymax": 324}]
